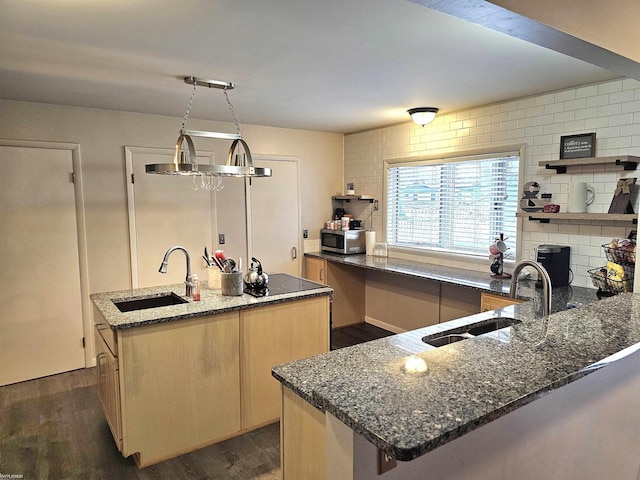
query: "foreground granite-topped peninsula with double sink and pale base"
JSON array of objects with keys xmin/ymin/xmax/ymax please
[{"xmin": 273, "ymin": 293, "xmax": 640, "ymax": 480}]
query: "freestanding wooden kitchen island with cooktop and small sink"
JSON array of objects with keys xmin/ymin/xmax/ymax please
[{"xmin": 91, "ymin": 274, "xmax": 332, "ymax": 467}]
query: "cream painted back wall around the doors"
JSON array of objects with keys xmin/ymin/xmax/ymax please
[{"xmin": 0, "ymin": 100, "xmax": 343, "ymax": 293}]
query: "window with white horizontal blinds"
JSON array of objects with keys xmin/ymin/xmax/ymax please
[{"xmin": 387, "ymin": 152, "xmax": 520, "ymax": 256}]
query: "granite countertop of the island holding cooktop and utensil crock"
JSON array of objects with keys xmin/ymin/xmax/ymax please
[{"xmin": 91, "ymin": 274, "xmax": 333, "ymax": 329}]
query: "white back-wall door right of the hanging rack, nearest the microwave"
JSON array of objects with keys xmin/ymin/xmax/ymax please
[{"xmin": 247, "ymin": 155, "xmax": 302, "ymax": 276}]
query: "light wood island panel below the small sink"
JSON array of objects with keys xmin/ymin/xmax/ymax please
[{"xmin": 118, "ymin": 312, "xmax": 240, "ymax": 466}]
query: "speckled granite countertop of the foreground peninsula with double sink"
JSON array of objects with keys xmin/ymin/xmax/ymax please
[{"xmin": 272, "ymin": 255, "xmax": 640, "ymax": 461}]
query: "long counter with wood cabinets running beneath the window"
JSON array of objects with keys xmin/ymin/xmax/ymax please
[{"xmin": 304, "ymin": 252, "xmax": 598, "ymax": 333}]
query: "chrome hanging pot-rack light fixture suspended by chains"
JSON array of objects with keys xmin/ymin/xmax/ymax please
[{"xmin": 145, "ymin": 77, "xmax": 271, "ymax": 179}]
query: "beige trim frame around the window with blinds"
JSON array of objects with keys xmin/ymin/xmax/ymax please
[{"xmin": 381, "ymin": 144, "xmax": 525, "ymax": 271}]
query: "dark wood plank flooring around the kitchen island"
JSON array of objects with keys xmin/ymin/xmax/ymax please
[{"xmin": 0, "ymin": 324, "xmax": 391, "ymax": 480}]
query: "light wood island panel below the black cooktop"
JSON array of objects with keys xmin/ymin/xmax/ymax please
[{"xmin": 240, "ymin": 296, "xmax": 329, "ymax": 430}]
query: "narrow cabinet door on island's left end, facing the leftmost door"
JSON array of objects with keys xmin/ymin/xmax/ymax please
[{"xmin": 94, "ymin": 325, "xmax": 122, "ymax": 450}]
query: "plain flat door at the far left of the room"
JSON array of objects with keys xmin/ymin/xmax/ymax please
[{"xmin": 0, "ymin": 146, "xmax": 85, "ymax": 385}]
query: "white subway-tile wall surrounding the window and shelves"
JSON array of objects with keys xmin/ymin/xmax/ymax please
[{"xmin": 344, "ymin": 79, "xmax": 640, "ymax": 287}]
